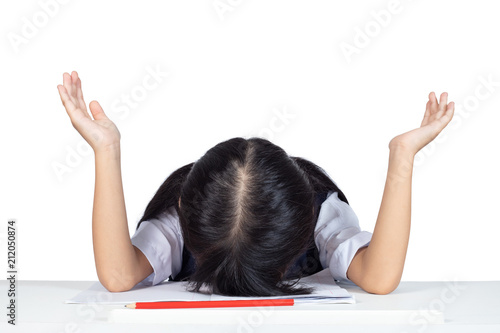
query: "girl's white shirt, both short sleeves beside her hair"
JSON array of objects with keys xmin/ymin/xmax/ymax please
[{"xmin": 131, "ymin": 192, "xmax": 372, "ymax": 285}]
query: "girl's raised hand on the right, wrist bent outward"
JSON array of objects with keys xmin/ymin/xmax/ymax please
[{"xmin": 389, "ymin": 92, "xmax": 455, "ymax": 154}]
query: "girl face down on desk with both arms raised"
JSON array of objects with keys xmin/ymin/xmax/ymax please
[{"xmin": 57, "ymin": 72, "xmax": 454, "ymax": 296}]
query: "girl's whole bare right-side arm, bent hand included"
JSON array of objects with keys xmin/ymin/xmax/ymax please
[{"xmin": 347, "ymin": 92, "xmax": 454, "ymax": 294}]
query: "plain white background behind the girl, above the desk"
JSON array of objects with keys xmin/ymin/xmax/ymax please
[{"xmin": 0, "ymin": 0, "xmax": 500, "ymax": 280}]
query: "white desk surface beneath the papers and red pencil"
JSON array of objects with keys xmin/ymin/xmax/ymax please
[{"xmin": 0, "ymin": 280, "xmax": 500, "ymax": 333}]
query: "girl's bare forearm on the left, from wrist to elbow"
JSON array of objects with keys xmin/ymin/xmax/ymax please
[{"xmin": 92, "ymin": 146, "xmax": 137, "ymax": 291}]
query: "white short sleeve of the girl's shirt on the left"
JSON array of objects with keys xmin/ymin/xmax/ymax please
[{"xmin": 131, "ymin": 207, "xmax": 184, "ymax": 285}]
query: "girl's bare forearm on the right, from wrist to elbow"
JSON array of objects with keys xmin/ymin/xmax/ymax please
[{"xmin": 363, "ymin": 146, "xmax": 414, "ymax": 293}]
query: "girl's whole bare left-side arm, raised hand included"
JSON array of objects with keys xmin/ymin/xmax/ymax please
[{"xmin": 57, "ymin": 72, "xmax": 153, "ymax": 291}]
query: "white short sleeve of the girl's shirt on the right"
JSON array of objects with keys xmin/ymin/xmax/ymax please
[{"xmin": 314, "ymin": 192, "xmax": 372, "ymax": 281}]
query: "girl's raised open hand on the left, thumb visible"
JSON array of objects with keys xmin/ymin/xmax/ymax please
[{"xmin": 57, "ymin": 72, "xmax": 120, "ymax": 153}]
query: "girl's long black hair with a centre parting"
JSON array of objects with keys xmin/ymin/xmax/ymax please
[{"xmin": 137, "ymin": 138, "xmax": 347, "ymax": 296}]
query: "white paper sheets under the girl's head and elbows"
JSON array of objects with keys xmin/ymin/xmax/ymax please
[{"xmin": 65, "ymin": 269, "xmax": 355, "ymax": 305}]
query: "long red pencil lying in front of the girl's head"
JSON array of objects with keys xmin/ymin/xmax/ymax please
[{"xmin": 125, "ymin": 299, "xmax": 294, "ymax": 309}]
